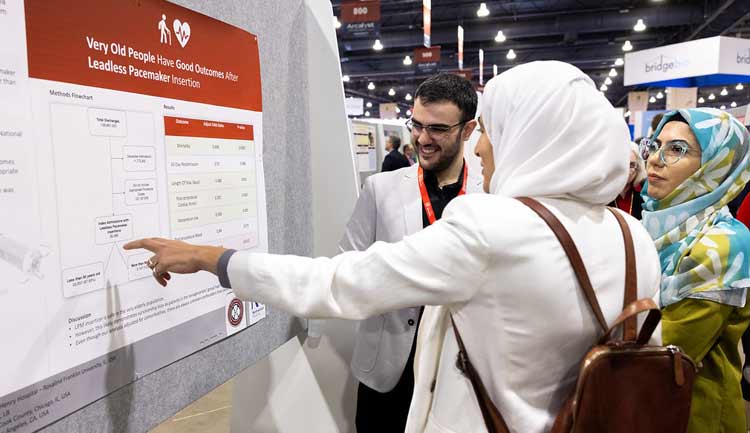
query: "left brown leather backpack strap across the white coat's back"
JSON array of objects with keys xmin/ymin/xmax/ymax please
[{"xmin": 518, "ymin": 197, "xmax": 609, "ymax": 332}]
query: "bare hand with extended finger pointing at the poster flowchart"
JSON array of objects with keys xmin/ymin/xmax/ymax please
[{"xmin": 123, "ymin": 238, "xmax": 226, "ymax": 286}]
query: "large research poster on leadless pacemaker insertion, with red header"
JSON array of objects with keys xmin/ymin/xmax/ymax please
[{"xmin": 0, "ymin": 0, "xmax": 268, "ymax": 433}]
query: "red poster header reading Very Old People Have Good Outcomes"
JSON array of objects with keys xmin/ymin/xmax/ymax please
[{"xmin": 26, "ymin": 0, "xmax": 262, "ymax": 111}]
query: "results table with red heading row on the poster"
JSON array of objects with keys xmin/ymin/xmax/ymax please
[{"xmin": 164, "ymin": 117, "xmax": 258, "ymax": 249}]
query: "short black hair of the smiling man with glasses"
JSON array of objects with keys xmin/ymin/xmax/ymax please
[{"xmin": 415, "ymin": 73, "xmax": 477, "ymax": 122}]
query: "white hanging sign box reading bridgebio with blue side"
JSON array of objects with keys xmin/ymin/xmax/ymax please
[{"xmin": 625, "ymin": 36, "xmax": 750, "ymax": 86}]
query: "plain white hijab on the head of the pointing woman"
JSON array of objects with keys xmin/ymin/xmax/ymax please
[{"xmin": 482, "ymin": 61, "xmax": 630, "ymax": 204}]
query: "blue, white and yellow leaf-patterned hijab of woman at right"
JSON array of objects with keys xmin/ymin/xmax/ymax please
[{"xmin": 642, "ymin": 108, "xmax": 750, "ymax": 307}]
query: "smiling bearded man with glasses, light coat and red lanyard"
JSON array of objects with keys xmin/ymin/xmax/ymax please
[{"xmin": 339, "ymin": 74, "xmax": 482, "ymax": 433}]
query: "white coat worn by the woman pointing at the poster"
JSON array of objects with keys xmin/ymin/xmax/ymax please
[{"xmin": 228, "ymin": 194, "xmax": 660, "ymax": 433}]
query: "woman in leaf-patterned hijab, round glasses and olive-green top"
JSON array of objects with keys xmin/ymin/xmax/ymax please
[{"xmin": 641, "ymin": 108, "xmax": 750, "ymax": 433}]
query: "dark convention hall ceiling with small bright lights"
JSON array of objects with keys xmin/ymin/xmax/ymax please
[{"xmin": 332, "ymin": 0, "xmax": 750, "ymax": 115}]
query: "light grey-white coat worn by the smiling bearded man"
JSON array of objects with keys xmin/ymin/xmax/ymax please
[{"xmin": 339, "ymin": 164, "xmax": 482, "ymax": 392}]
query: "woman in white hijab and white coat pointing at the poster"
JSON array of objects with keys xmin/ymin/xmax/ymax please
[{"xmin": 126, "ymin": 62, "xmax": 660, "ymax": 433}]
